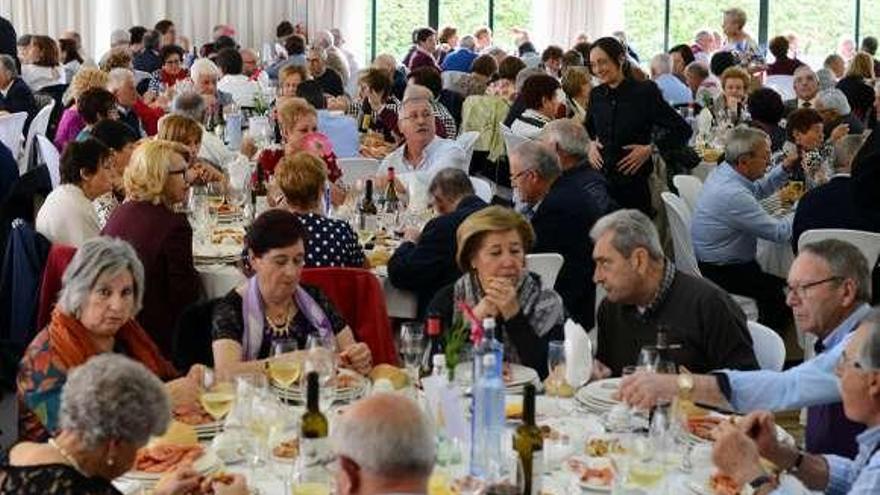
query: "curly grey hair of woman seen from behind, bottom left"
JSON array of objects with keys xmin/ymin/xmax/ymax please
[{"xmin": 58, "ymin": 353, "xmax": 171, "ymax": 449}]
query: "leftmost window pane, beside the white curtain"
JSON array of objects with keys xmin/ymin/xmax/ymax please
[{"xmin": 375, "ymin": 0, "xmax": 428, "ymax": 63}]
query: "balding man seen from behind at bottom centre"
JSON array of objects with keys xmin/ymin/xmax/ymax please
[{"xmin": 330, "ymin": 394, "xmax": 435, "ymax": 495}]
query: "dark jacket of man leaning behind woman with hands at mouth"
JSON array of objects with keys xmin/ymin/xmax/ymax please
[{"xmin": 388, "ymin": 196, "xmax": 486, "ymax": 315}]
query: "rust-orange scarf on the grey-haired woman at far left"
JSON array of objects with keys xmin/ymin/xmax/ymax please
[{"xmin": 48, "ymin": 308, "xmax": 177, "ymax": 380}]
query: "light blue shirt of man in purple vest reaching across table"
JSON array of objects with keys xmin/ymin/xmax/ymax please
[{"xmin": 723, "ymin": 304, "xmax": 871, "ymax": 412}]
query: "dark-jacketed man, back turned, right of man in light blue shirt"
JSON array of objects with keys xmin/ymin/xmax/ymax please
[{"xmin": 791, "ymin": 135, "xmax": 880, "ymax": 252}]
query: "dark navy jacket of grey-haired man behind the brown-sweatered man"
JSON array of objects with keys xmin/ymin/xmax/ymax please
[{"xmin": 532, "ymin": 166, "xmax": 607, "ymax": 329}]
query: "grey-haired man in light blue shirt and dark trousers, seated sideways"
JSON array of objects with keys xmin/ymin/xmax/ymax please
[{"xmin": 691, "ymin": 127, "xmax": 797, "ymax": 333}]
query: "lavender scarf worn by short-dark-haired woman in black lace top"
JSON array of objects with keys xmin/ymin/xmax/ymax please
[{"xmin": 241, "ymin": 276, "xmax": 333, "ymax": 361}]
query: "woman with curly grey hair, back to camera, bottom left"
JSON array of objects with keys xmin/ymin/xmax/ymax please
[{"xmin": 10, "ymin": 354, "xmax": 247, "ymax": 495}]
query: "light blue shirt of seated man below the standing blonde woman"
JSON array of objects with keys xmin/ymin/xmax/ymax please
[{"xmin": 691, "ymin": 162, "xmax": 794, "ymax": 265}]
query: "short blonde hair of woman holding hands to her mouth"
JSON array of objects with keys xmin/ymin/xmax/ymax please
[{"xmin": 455, "ymin": 205, "xmax": 535, "ymax": 272}]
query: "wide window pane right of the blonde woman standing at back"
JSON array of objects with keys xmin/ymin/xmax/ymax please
[{"xmin": 768, "ymin": 0, "xmax": 852, "ymax": 68}]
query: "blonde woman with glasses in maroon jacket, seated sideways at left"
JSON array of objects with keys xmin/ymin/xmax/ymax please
[{"xmin": 102, "ymin": 139, "xmax": 201, "ymax": 358}]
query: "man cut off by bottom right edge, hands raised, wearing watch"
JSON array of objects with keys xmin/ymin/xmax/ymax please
[{"xmin": 712, "ymin": 309, "xmax": 880, "ymax": 495}]
